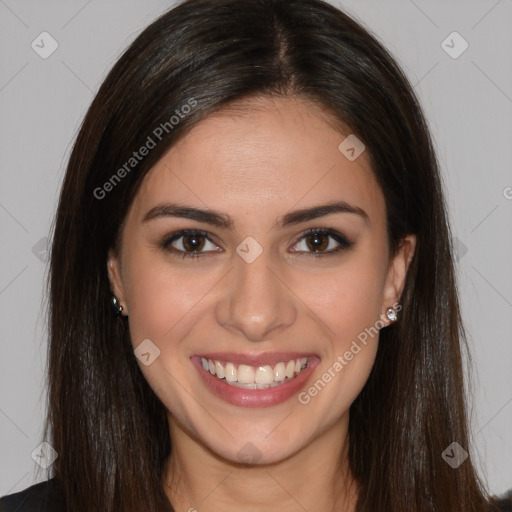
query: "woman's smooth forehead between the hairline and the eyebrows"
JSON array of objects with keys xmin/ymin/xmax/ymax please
[{"xmin": 128, "ymin": 94, "xmax": 384, "ymax": 226}]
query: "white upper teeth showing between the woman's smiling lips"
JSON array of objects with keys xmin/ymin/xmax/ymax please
[{"xmin": 201, "ymin": 357, "xmax": 308, "ymax": 389}]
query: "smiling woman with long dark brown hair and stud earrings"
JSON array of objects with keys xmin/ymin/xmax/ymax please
[{"xmin": 1, "ymin": 0, "xmax": 511, "ymax": 512}]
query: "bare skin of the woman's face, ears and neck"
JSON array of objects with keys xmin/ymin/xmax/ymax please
[{"xmin": 108, "ymin": 97, "xmax": 416, "ymax": 512}]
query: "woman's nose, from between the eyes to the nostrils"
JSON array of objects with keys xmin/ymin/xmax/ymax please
[{"xmin": 216, "ymin": 250, "xmax": 297, "ymax": 341}]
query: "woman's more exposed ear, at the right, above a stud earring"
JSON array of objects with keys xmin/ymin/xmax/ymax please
[{"xmin": 381, "ymin": 235, "xmax": 416, "ymax": 326}]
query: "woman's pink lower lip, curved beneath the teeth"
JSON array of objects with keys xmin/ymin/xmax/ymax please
[{"xmin": 191, "ymin": 356, "xmax": 319, "ymax": 407}]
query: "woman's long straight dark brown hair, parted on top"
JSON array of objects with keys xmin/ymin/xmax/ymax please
[{"xmin": 46, "ymin": 0, "xmax": 498, "ymax": 512}]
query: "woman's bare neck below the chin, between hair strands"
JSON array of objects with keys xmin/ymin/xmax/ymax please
[{"xmin": 164, "ymin": 414, "xmax": 357, "ymax": 512}]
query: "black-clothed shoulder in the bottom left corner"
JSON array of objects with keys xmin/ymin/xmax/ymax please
[{"xmin": 0, "ymin": 478, "xmax": 65, "ymax": 512}]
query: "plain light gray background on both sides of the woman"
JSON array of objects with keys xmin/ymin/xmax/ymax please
[{"xmin": 0, "ymin": 0, "xmax": 512, "ymax": 495}]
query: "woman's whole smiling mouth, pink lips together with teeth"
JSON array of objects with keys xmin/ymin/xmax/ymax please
[{"xmin": 190, "ymin": 352, "xmax": 320, "ymax": 407}]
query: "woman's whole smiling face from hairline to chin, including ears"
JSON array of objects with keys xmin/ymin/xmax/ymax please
[{"xmin": 108, "ymin": 94, "xmax": 415, "ymax": 464}]
